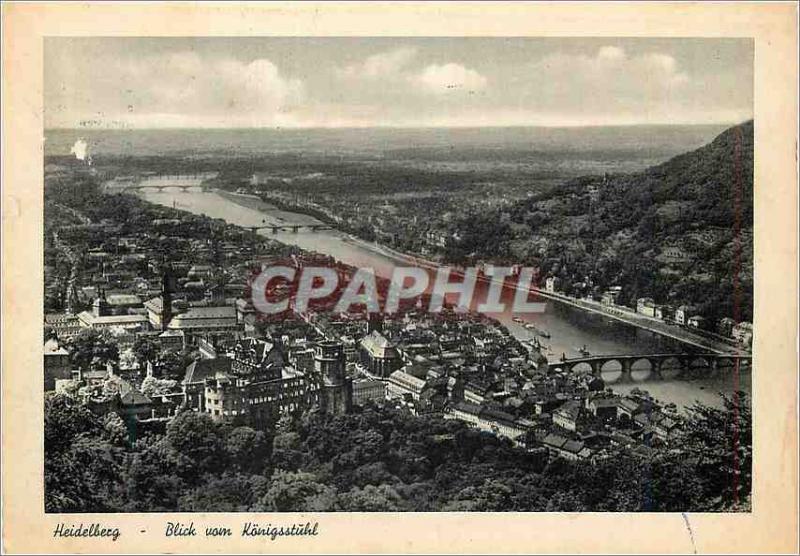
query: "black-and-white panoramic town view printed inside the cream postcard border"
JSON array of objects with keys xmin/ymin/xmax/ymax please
[{"xmin": 37, "ymin": 37, "xmax": 760, "ymax": 516}]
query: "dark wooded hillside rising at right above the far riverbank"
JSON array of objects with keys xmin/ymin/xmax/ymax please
[{"xmin": 448, "ymin": 121, "xmax": 753, "ymax": 322}]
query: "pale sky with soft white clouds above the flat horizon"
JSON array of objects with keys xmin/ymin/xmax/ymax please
[{"xmin": 44, "ymin": 38, "xmax": 753, "ymax": 128}]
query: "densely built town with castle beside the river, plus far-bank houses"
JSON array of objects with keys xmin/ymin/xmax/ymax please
[{"xmin": 44, "ymin": 162, "xmax": 750, "ymax": 474}]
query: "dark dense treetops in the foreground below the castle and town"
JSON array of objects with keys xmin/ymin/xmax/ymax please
[{"xmin": 44, "ymin": 393, "xmax": 752, "ymax": 512}]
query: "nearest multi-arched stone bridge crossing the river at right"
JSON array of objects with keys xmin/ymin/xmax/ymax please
[{"xmin": 550, "ymin": 353, "xmax": 752, "ymax": 383}]
